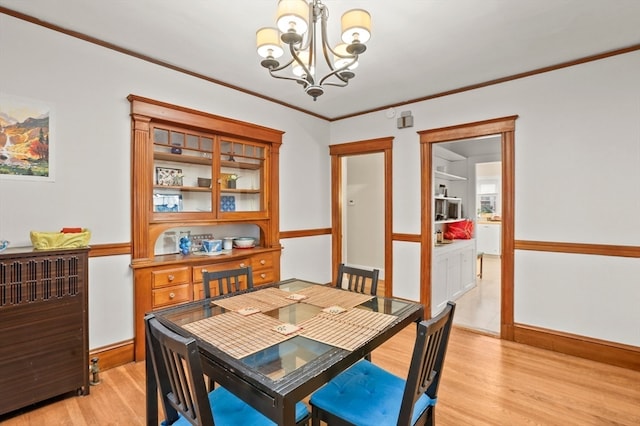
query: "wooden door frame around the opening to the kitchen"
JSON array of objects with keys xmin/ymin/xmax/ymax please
[{"xmin": 418, "ymin": 116, "xmax": 517, "ymax": 340}]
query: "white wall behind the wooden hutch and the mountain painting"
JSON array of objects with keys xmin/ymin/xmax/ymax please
[{"xmin": 0, "ymin": 14, "xmax": 331, "ymax": 349}]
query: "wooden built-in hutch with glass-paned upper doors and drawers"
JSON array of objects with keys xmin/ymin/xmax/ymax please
[{"xmin": 127, "ymin": 95, "xmax": 283, "ymax": 360}]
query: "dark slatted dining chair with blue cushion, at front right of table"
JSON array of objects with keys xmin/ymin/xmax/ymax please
[{"xmin": 309, "ymin": 302, "xmax": 455, "ymax": 426}]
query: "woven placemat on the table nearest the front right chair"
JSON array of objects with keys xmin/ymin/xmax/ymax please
[{"xmin": 300, "ymin": 309, "xmax": 397, "ymax": 351}]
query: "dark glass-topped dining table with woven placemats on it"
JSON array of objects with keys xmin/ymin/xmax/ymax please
[{"xmin": 146, "ymin": 278, "xmax": 424, "ymax": 426}]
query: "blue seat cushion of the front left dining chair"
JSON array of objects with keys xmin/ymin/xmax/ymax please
[{"xmin": 162, "ymin": 387, "xmax": 309, "ymax": 426}]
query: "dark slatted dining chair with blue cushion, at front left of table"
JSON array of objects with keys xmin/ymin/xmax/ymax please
[{"xmin": 144, "ymin": 314, "xmax": 309, "ymax": 426}]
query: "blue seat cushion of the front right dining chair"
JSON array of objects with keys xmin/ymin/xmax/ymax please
[{"xmin": 310, "ymin": 360, "xmax": 435, "ymax": 426}]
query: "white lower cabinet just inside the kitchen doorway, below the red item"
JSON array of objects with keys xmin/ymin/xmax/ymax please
[{"xmin": 431, "ymin": 239, "xmax": 476, "ymax": 315}]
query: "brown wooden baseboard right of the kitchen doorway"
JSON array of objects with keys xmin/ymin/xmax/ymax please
[{"xmin": 514, "ymin": 324, "xmax": 640, "ymax": 371}]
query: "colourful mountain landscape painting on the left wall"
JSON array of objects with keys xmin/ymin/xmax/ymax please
[{"xmin": 0, "ymin": 95, "xmax": 51, "ymax": 180}]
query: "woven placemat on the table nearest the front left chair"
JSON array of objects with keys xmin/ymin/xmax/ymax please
[{"xmin": 183, "ymin": 312, "xmax": 298, "ymax": 358}]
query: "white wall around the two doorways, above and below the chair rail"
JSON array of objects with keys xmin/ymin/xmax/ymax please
[{"xmin": 331, "ymin": 52, "xmax": 640, "ymax": 346}]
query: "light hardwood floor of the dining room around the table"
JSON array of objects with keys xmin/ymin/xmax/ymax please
[{"xmin": 0, "ymin": 326, "xmax": 640, "ymax": 426}]
